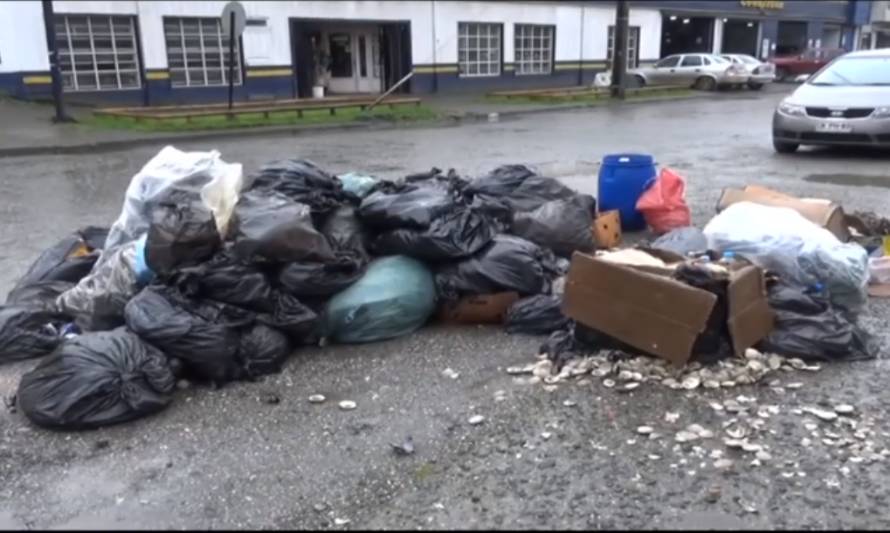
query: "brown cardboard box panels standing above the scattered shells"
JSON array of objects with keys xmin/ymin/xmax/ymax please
[{"xmin": 562, "ymin": 252, "xmax": 775, "ymax": 366}]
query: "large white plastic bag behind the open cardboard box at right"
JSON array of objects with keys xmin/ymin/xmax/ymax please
[{"xmin": 704, "ymin": 202, "xmax": 869, "ymax": 311}]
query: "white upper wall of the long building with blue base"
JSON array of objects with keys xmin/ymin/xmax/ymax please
[{"xmin": 0, "ymin": 0, "xmax": 661, "ymax": 72}]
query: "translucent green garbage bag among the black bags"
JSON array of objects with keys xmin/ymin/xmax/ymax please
[{"xmin": 324, "ymin": 255, "xmax": 436, "ymax": 343}]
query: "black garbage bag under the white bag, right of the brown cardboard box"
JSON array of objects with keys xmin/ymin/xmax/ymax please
[{"xmin": 758, "ymin": 284, "xmax": 880, "ymax": 361}]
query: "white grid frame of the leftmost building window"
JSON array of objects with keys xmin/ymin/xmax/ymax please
[{"xmin": 53, "ymin": 13, "xmax": 145, "ymax": 93}]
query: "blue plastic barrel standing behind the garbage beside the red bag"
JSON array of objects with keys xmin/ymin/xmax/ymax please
[{"xmin": 598, "ymin": 154, "xmax": 655, "ymax": 231}]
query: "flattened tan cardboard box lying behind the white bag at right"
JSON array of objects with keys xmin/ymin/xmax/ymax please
[{"xmin": 717, "ymin": 185, "xmax": 850, "ymax": 242}]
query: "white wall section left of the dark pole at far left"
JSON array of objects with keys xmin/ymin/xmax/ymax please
[{"xmin": 0, "ymin": 1, "xmax": 49, "ymax": 72}]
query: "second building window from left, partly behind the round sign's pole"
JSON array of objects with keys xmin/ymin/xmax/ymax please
[{"xmin": 164, "ymin": 17, "xmax": 241, "ymax": 87}]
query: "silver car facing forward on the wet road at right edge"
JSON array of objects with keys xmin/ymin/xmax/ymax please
[{"xmin": 773, "ymin": 48, "xmax": 890, "ymax": 153}]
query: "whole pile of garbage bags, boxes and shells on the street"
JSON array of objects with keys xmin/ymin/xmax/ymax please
[{"xmin": 0, "ymin": 147, "xmax": 884, "ymax": 429}]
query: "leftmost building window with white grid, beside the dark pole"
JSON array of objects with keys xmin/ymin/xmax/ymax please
[{"xmin": 55, "ymin": 15, "xmax": 140, "ymax": 91}]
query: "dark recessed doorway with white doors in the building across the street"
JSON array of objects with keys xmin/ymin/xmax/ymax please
[{"xmin": 290, "ymin": 19, "xmax": 411, "ymax": 98}]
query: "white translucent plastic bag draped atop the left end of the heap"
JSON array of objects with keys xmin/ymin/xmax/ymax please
[{"xmin": 105, "ymin": 146, "xmax": 244, "ymax": 252}]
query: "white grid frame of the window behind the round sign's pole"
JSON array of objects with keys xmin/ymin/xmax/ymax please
[{"xmin": 161, "ymin": 15, "xmax": 244, "ymax": 89}]
